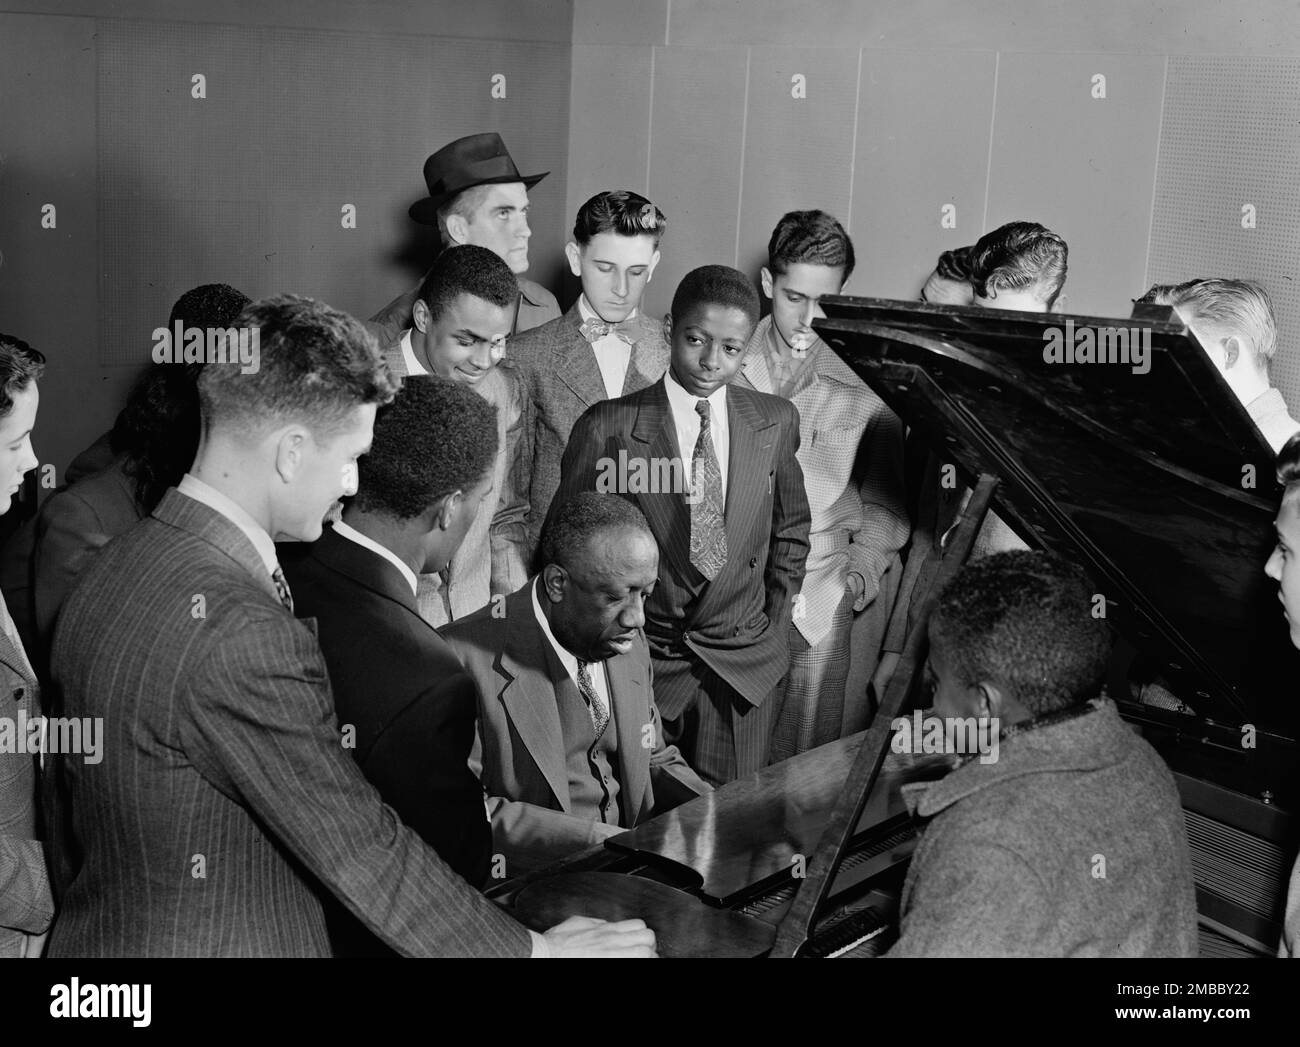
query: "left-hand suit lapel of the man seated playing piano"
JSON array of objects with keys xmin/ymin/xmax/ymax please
[{"xmin": 494, "ymin": 583, "xmax": 569, "ymax": 810}]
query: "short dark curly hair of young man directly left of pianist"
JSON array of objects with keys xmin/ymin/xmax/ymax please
[{"xmin": 351, "ymin": 375, "xmax": 498, "ymax": 520}]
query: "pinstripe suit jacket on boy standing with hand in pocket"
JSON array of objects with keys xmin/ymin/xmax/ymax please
[{"xmin": 555, "ymin": 378, "xmax": 810, "ymax": 719}]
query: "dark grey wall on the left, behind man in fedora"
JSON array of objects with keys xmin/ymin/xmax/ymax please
[{"xmin": 0, "ymin": 0, "xmax": 572, "ymax": 481}]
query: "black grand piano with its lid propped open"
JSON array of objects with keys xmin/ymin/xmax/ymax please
[{"xmin": 490, "ymin": 297, "xmax": 1300, "ymax": 957}]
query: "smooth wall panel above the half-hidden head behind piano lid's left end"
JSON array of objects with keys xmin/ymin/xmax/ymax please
[{"xmin": 848, "ymin": 51, "xmax": 997, "ymax": 298}]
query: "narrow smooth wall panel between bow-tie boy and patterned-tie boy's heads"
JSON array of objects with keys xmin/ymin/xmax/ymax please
[{"xmin": 646, "ymin": 47, "xmax": 746, "ymax": 316}]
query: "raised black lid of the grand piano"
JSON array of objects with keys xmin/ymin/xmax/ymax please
[{"xmin": 815, "ymin": 297, "xmax": 1300, "ymax": 737}]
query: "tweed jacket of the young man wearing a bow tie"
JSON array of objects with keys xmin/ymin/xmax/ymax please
[{"xmin": 507, "ymin": 302, "xmax": 668, "ymax": 558}]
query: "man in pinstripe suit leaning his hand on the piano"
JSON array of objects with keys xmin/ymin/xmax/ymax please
[{"xmin": 51, "ymin": 297, "xmax": 653, "ymax": 956}]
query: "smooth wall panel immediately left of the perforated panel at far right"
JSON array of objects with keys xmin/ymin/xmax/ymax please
[{"xmin": 985, "ymin": 53, "xmax": 1165, "ymax": 316}]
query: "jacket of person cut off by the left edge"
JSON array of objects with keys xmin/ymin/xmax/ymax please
[{"xmin": 0, "ymin": 587, "xmax": 55, "ymax": 959}]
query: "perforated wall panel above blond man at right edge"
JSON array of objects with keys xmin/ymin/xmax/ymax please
[{"xmin": 1147, "ymin": 57, "xmax": 1300, "ymax": 415}]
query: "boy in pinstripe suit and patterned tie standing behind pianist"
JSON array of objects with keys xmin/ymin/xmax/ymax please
[{"xmin": 555, "ymin": 265, "xmax": 810, "ymax": 784}]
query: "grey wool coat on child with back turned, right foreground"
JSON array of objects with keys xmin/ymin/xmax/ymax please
[{"xmin": 889, "ymin": 698, "xmax": 1196, "ymax": 956}]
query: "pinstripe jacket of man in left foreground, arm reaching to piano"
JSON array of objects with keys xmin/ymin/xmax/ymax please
[{"xmin": 51, "ymin": 489, "xmax": 530, "ymax": 956}]
